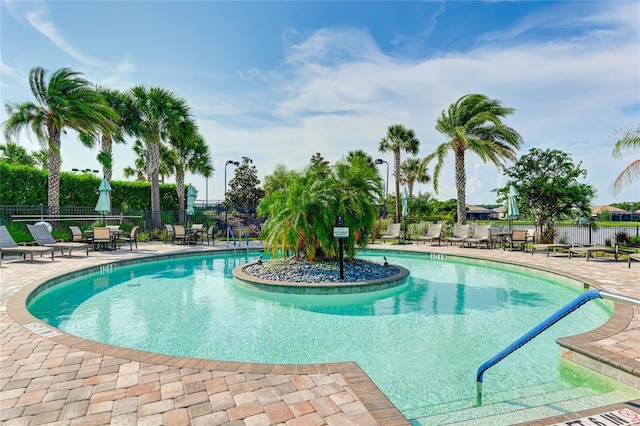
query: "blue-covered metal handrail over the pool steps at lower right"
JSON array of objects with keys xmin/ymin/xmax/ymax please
[{"xmin": 476, "ymin": 289, "xmax": 640, "ymax": 405}]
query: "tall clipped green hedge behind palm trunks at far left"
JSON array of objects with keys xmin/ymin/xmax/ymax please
[{"xmin": 0, "ymin": 161, "xmax": 178, "ymax": 210}]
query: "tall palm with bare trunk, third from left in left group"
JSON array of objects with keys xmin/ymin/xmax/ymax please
[{"xmin": 129, "ymin": 86, "xmax": 192, "ymax": 229}]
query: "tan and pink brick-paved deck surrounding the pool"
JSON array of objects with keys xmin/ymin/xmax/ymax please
[{"xmin": 0, "ymin": 243, "xmax": 640, "ymax": 425}]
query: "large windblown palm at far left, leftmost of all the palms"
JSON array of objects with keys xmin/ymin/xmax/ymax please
[{"xmin": 4, "ymin": 67, "xmax": 118, "ymax": 217}]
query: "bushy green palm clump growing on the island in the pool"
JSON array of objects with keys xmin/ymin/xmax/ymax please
[{"xmin": 258, "ymin": 156, "xmax": 382, "ymax": 261}]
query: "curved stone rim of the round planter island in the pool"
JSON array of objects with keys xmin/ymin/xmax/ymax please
[{"xmin": 232, "ymin": 262, "xmax": 409, "ymax": 295}]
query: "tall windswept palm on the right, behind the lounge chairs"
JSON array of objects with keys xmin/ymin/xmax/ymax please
[{"xmin": 422, "ymin": 94, "xmax": 522, "ymax": 224}]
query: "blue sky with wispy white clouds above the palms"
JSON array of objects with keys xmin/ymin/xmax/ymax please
[{"xmin": 0, "ymin": 0, "xmax": 640, "ymax": 204}]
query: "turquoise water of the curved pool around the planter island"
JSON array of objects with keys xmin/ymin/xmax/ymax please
[{"xmin": 28, "ymin": 253, "xmax": 632, "ymax": 418}]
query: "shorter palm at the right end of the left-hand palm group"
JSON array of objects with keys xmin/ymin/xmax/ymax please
[{"xmin": 167, "ymin": 121, "xmax": 213, "ymax": 221}]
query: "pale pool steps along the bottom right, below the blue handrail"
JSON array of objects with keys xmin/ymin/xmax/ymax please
[{"xmin": 411, "ymin": 387, "xmax": 637, "ymax": 426}]
